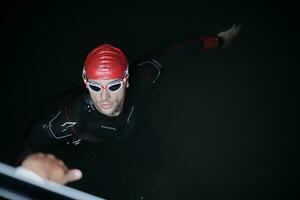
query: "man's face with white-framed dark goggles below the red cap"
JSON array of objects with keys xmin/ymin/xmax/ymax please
[{"xmin": 86, "ymin": 79, "xmax": 128, "ymax": 116}]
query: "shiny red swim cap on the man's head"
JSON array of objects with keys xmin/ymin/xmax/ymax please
[{"xmin": 83, "ymin": 44, "xmax": 128, "ymax": 80}]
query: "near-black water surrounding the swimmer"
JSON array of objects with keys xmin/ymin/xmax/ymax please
[{"xmin": 0, "ymin": 0, "xmax": 299, "ymax": 199}]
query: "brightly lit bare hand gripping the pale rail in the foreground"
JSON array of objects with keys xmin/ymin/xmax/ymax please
[{"xmin": 21, "ymin": 153, "xmax": 82, "ymax": 184}]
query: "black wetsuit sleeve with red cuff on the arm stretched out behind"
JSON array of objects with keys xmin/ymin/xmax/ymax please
[{"xmin": 130, "ymin": 36, "xmax": 224, "ymax": 87}]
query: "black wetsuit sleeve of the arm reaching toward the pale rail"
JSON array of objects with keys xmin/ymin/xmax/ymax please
[{"xmin": 12, "ymin": 95, "xmax": 73, "ymax": 166}]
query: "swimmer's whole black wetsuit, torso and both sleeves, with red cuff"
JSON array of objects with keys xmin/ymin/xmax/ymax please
[{"xmin": 16, "ymin": 36, "xmax": 224, "ymax": 163}]
